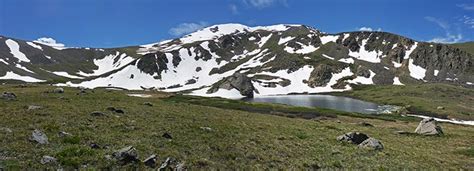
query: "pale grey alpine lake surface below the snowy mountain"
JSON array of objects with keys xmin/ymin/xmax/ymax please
[{"xmin": 245, "ymin": 95, "xmax": 378, "ymax": 114}]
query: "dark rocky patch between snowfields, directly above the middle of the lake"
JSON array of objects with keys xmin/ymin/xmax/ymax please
[{"xmin": 308, "ymin": 64, "xmax": 332, "ymax": 87}]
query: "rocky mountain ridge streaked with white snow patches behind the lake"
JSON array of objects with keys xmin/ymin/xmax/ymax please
[{"xmin": 0, "ymin": 24, "xmax": 474, "ymax": 98}]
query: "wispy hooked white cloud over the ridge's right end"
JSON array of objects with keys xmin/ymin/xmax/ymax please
[{"xmin": 425, "ymin": 16, "xmax": 463, "ymax": 43}]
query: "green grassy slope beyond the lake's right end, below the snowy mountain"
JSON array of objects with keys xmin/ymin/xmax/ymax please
[{"xmin": 330, "ymin": 84, "xmax": 474, "ymax": 120}]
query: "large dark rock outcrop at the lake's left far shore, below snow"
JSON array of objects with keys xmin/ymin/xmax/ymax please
[{"xmin": 208, "ymin": 72, "xmax": 255, "ymax": 98}]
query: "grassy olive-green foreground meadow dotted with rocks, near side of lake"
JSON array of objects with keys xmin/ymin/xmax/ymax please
[{"xmin": 0, "ymin": 86, "xmax": 474, "ymax": 169}]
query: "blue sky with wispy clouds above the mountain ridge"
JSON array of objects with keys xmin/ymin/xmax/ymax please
[{"xmin": 0, "ymin": 0, "xmax": 474, "ymax": 47}]
